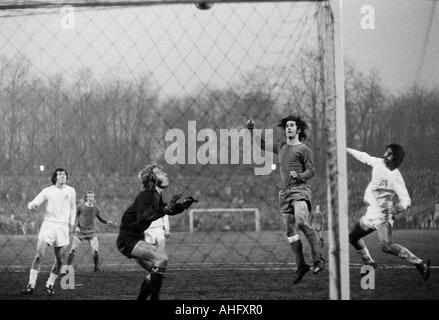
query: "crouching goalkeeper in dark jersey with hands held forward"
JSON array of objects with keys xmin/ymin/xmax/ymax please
[{"xmin": 117, "ymin": 164, "xmax": 197, "ymax": 300}]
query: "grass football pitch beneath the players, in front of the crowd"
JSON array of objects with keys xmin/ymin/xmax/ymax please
[{"xmin": 0, "ymin": 230, "xmax": 439, "ymax": 300}]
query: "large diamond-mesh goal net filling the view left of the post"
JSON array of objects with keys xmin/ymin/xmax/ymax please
[{"xmin": 0, "ymin": 0, "xmax": 340, "ymax": 299}]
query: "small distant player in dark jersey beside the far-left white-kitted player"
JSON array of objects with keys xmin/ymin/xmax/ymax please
[{"xmin": 67, "ymin": 191, "xmax": 113, "ymax": 272}]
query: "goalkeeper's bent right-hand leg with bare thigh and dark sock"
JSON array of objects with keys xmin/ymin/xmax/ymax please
[{"xmin": 131, "ymin": 241, "xmax": 168, "ymax": 300}]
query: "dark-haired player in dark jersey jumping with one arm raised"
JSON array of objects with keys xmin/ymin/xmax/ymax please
[{"xmin": 247, "ymin": 116, "xmax": 325, "ymax": 283}]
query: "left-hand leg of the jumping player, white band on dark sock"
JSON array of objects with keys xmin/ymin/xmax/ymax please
[{"xmin": 282, "ymin": 213, "xmax": 310, "ymax": 284}]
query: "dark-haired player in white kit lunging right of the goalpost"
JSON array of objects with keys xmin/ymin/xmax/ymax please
[{"xmin": 347, "ymin": 143, "xmax": 430, "ymax": 281}]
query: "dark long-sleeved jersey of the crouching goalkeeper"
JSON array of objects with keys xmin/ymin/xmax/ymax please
[{"xmin": 119, "ymin": 190, "xmax": 186, "ymax": 239}]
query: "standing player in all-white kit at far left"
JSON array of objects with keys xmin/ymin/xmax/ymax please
[{"xmin": 22, "ymin": 168, "xmax": 76, "ymax": 296}]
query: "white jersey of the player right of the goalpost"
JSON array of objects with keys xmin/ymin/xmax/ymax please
[{"xmin": 347, "ymin": 148, "xmax": 411, "ymax": 213}]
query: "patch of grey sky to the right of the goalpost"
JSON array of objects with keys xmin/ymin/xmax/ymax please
[{"xmin": 343, "ymin": 0, "xmax": 439, "ymax": 93}]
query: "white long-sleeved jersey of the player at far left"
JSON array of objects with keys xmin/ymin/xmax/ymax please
[{"xmin": 27, "ymin": 185, "xmax": 76, "ymax": 225}]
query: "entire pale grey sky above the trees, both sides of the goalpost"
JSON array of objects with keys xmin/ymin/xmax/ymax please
[{"xmin": 0, "ymin": 0, "xmax": 439, "ymax": 95}]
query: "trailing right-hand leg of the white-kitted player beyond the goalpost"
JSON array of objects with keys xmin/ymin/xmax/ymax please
[{"xmin": 377, "ymin": 221, "xmax": 430, "ymax": 281}]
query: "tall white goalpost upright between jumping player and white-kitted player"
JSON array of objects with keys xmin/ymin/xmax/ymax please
[{"xmin": 319, "ymin": 0, "xmax": 350, "ymax": 300}]
